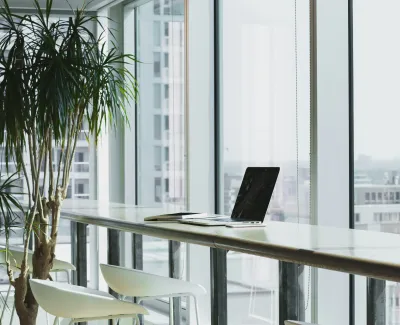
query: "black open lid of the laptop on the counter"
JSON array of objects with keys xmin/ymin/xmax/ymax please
[{"xmin": 231, "ymin": 167, "xmax": 280, "ymax": 222}]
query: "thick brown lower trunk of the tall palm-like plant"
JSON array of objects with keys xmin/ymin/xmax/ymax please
[{"xmin": 15, "ymin": 207, "xmax": 59, "ymax": 325}]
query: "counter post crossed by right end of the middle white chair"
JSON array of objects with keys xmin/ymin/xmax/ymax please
[{"xmin": 168, "ymin": 240, "xmax": 182, "ymax": 325}]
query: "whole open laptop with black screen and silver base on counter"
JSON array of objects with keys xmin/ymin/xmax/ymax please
[{"xmin": 179, "ymin": 167, "xmax": 280, "ymax": 226}]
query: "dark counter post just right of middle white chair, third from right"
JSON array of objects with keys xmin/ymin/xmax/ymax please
[{"xmin": 211, "ymin": 248, "xmax": 228, "ymax": 325}]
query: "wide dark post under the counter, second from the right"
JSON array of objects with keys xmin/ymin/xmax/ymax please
[{"xmin": 279, "ymin": 262, "xmax": 305, "ymax": 325}]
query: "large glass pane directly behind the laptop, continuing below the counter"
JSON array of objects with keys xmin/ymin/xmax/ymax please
[{"xmin": 219, "ymin": 0, "xmax": 310, "ymax": 325}]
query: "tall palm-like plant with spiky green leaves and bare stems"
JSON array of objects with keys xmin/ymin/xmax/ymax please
[{"xmin": 0, "ymin": 0, "xmax": 137, "ymax": 325}]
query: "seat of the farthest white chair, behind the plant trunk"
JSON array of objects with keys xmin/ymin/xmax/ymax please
[{"xmin": 0, "ymin": 247, "xmax": 75, "ymax": 272}]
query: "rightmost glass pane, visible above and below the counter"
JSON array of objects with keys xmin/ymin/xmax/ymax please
[{"xmin": 353, "ymin": 0, "xmax": 400, "ymax": 325}]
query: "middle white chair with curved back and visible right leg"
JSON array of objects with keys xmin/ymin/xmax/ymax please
[{"xmin": 100, "ymin": 264, "xmax": 206, "ymax": 325}]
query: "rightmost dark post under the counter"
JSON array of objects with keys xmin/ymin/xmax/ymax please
[{"xmin": 367, "ymin": 278, "xmax": 386, "ymax": 325}]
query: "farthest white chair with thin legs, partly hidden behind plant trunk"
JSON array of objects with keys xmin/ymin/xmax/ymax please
[{"xmin": 0, "ymin": 247, "xmax": 76, "ymax": 324}]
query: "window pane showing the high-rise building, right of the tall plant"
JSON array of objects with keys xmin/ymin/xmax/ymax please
[{"xmin": 124, "ymin": 0, "xmax": 186, "ymax": 324}]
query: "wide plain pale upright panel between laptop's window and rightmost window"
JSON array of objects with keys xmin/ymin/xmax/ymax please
[{"xmin": 312, "ymin": 0, "xmax": 352, "ymax": 325}]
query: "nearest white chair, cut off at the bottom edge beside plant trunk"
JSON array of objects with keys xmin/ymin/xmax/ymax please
[{"xmin": 30, "ymin": 279, "xmax": 148, "ymax": 325}]
